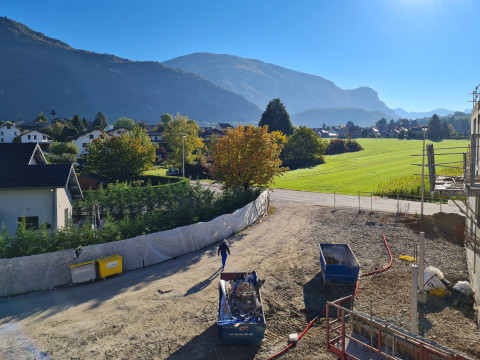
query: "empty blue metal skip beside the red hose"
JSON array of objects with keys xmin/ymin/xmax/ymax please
[{"xmin": 320, "ymin": 244, "xmax": 360, "ymax": 285}]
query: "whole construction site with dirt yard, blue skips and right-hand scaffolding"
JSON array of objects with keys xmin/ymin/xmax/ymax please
[{"xmin": 0, "ymin": 87, "xmax": 480, "ymax": 360}]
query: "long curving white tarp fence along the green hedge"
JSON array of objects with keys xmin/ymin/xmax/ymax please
[{"xmin": 0, "ymin": 190, "xmax": 269, "ymax": 296}]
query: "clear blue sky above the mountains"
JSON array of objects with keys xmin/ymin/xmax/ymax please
[{"xmin": 0, "ymin": 0, "xmax": 480, "ymax": 111}]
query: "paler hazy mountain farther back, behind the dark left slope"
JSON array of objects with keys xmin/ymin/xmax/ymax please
[{"xmin": 164, "ymin": 53, "xmax": 398, "ymax": 125}]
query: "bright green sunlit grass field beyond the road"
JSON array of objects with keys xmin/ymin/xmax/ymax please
[{"xmin": 273, "ymin": 139, "xmax": 470, "ymax": 195}]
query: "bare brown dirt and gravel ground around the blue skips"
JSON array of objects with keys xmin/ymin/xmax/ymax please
[{"xmin": 0, "ymin": 203, "xmax": 480, "ymax": 360}]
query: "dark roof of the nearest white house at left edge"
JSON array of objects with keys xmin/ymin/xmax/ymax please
[{"xmin": 0, "ymin": 143, "xmax": 83, "ymax": 198}]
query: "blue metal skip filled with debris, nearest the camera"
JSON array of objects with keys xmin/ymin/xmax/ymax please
[{"xmin": 217, "ymin": 272, "xmax": 266, "ymax": 345}]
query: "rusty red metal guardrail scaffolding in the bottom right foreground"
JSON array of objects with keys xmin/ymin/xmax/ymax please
[{"xmin": 326, "ymin": 295, "xmax": 470, "ymax": 360}]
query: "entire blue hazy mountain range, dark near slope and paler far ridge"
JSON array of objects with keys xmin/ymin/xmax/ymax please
[{"xmin": 0, "ymin": 17, "xmax": 460, "ymax": 127}]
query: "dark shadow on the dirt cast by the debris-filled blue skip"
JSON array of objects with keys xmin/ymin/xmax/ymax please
[{"xmin": 166, "ymin": 324, "xmax": 260, "ymax": 360}]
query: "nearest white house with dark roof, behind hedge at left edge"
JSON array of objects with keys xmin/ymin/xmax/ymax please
[{"xmin": 0, "ymin": 143, "xmax": 83, "ymax": 235}]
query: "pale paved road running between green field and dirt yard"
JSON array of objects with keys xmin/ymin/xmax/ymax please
[{"xmin": 194, "ymin": 182, "xmax": 465, "ymax": 215}]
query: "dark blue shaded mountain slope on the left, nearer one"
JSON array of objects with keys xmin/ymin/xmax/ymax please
[{"xmin": 0, "ymin": 17, "xmax": 262, "ymax": 124}]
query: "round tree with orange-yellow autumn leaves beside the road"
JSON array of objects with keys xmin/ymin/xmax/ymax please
[{"xmin": 212, "ymin": 126, "xmax": 288, "ymax": 190}]
